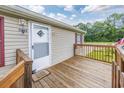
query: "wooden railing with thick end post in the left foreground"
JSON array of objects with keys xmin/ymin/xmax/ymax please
[{"xmin": 0, "ymin": 49, "xmax": 32, "ymax": 88}]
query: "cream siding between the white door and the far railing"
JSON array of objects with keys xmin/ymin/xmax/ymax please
[{"xmin": 52, "ymin": 27, "xmax": 75, "ymax": 64}]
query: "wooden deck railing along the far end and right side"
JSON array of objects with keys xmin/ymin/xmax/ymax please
[{"xmin": 74, "ymin": 44, "xmax": 124, "ymax": 88}]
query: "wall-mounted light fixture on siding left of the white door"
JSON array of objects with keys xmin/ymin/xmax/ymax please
[{"xmin": 19, "ymin": 19, "xmax": 28, "ymax": 34}]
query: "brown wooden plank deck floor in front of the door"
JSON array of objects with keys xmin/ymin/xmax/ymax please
[{"xmin": 32, "ymin": 56, "xmax": 111, "ymax": 88}]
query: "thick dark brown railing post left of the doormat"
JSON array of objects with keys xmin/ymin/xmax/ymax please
[{"xmin": 24, "ymin": 61, "xmax": 32, "ymax": 88}]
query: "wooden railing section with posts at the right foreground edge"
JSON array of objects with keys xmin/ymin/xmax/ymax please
[{"xmin": 112, "ymin": 47, "xmax": 124, "ymax": 88}]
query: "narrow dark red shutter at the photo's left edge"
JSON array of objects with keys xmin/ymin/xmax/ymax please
[{"xmin": 0, "ymin": 16, "xmax": 5, "ymax": 67}]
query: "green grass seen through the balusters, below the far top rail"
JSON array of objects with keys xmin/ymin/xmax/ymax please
[{"xmin": 87, "ymin": 49, "xmax": 115, "ymax": 63}]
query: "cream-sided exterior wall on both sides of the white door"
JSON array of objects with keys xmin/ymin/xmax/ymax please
[{"xmin": 0, "ymin": 15, "xmax": 83, "ymax": 65}]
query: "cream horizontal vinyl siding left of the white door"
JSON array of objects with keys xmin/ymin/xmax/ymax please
[{"xmin": 0, "ymin": 15, "xmax": 28, "ymax": 65}]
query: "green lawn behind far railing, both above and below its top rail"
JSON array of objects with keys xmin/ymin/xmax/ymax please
[{"xmin": 85, "ymin": 42, "xmax": 115, "ymax": 63}]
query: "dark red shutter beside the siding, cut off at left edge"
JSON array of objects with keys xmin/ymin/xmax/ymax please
[{"xmin": 0, "ymin": 17, "xmax": 4, "ymax": 66}]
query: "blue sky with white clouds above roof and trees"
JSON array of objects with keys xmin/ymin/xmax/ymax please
[{"xmin": 22, "ymin": 5, "xmax": 124, "ymax": 25}]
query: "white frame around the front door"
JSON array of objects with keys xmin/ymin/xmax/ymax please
[{"xmin": 28, "ymin": 21, "xmax": 52, "ymax": 68}]
